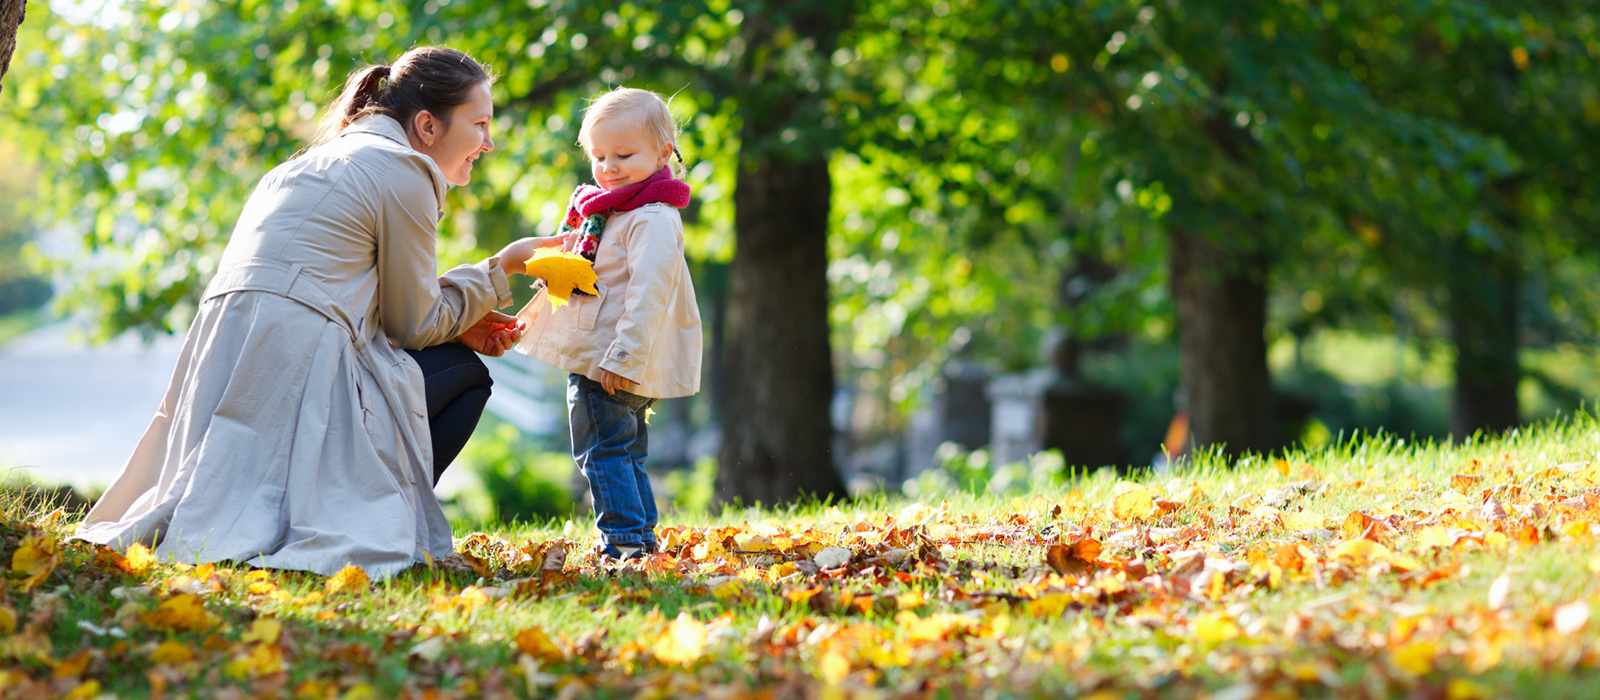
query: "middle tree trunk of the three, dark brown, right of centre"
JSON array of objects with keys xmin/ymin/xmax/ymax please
[{"xmin": 1170, "ymin": 230, "xmax": 1282, "ymax": 454}]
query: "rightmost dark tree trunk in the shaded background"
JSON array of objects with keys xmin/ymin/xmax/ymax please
[{"xmin": 1450, "ymin": 242, "xmax": 1522, "ymax": 439}]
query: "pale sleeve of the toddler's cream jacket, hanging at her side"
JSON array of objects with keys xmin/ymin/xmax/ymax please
[{"xmin": 600, "ymin": 213, "xmax": 683, "ymax": 382}]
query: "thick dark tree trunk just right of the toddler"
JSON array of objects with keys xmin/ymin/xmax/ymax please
[{"xmin": 717, "ymin": 147, "xmax": 846, "ymax": 505}]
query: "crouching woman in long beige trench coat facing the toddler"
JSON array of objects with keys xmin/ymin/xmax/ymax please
[{"xmin": 77, "ymin": 46, "xmax": 557, "ymax": 577}]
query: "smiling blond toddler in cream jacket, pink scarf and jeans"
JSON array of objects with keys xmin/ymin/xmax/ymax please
[{"xmin": 517, "ymin": 88, "xmax": 701, "ymax": 559}]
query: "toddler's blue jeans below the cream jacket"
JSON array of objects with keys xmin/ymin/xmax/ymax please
[{"xmin": 566, "ymin": 374, "xmax": 656, "ymax": 550}]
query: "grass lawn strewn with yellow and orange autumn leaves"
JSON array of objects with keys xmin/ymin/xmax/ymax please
[{"xmin": 0, "ymin": 416, "xmax": 1600, "ymax": 698}]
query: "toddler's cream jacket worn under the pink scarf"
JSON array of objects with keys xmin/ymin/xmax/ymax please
[{"xmin": 517, "ymin": 205, "xmax": 701, "ymax": 398}]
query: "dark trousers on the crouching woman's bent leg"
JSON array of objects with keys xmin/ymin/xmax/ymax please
[{"xmin": 406, "ymin": 342, "xmax": 494, "ymax": 486}]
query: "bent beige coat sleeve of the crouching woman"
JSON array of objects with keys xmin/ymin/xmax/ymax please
[{"xmin": 378, "ymin": 155, "xmax": 510, "ymax": 350}]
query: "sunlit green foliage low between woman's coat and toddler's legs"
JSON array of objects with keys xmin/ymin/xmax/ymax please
[{"xmin": 451, "ymin": 422, "xmax": 573, "ymax": 524}]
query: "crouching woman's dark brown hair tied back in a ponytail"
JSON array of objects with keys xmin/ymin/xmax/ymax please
[{"xmin": 314, "ymin": 46, "xmax": 494, "ymax": 144}]
